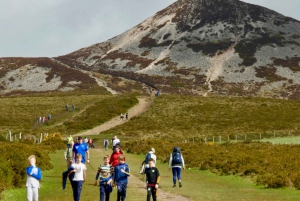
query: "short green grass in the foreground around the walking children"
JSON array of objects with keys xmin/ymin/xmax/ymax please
[{"xmin": 3, "ymin": 146, "xmax": 300, "ymax": 201}]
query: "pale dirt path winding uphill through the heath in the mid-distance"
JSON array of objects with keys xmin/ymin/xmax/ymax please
[{"xmin": 74, "ymin": 97, "xmax": 154, "ymax": 136}]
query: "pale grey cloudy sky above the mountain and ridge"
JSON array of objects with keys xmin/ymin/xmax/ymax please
[{"xmin": 0, "ymin": 0, "xmax": 300, "ymax": 57}]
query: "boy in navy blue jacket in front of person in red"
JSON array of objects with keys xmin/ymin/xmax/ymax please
[{"xmin": 113, "ymin": 154, "xmax": 130, "ymax": 201}]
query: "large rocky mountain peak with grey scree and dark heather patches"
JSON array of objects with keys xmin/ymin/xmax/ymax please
[{"xmin": 0, "ymin": 0, "xmax": 300, "ymax": 99}]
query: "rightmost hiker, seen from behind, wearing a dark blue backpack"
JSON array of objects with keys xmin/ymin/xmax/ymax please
[{"xmin": 169, "ymin": 147, "xmax": 185, "ymax": 187}]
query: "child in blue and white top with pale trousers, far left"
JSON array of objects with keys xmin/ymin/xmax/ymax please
[{"xmin": 26, "ymin": 155, "xmax": 42, "ymax": 201}]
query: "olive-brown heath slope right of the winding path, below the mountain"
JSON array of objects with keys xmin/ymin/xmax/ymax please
[{"xmin": 102, "ymin": 95, "xmax": 300, "ymax": 142}]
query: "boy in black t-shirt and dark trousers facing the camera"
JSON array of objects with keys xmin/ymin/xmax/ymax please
[{"xmin": 145, "ymin": 158, "xmax": 160, "ymax": 201}]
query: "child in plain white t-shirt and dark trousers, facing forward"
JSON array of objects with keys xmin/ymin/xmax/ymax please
[{"xmin": 69, "ymin": 154, "xmax": 87, "ymax": 201}]
